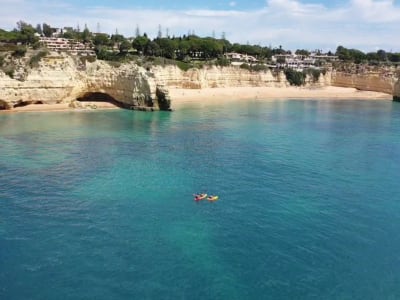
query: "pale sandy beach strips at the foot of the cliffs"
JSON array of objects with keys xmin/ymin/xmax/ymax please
[{"xmin": 0, "ymin": 86, "xmax": 393, "ymax": 113}]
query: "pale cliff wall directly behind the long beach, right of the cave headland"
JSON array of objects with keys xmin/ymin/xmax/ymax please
[{"xmin": 152, "ymin": 66, "xmax": 400, "ymax": 99}]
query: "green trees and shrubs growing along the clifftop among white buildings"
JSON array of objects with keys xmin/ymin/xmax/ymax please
[{"xmin": 0, "ymin": 21, "xmax": 400, "ymax": 77}]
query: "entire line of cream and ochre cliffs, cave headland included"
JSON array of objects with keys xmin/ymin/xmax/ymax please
[{"xmin": 0, "ymin": 53, "xmax": 400, "ymax": 110}]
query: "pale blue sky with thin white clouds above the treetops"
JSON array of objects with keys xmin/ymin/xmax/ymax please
[{"xmin": 0, "ymin": 0, "xmax": 400, "ymax": 52}]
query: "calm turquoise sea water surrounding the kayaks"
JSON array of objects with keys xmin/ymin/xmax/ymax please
[{"xmin": 0, "ymin": 100, "xmax": 400, "ymax": 299}]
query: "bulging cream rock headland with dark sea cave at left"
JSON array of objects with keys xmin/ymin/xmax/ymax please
[{"xmin": 0, "ymin": 54, "xmax": 163, "ymax": 108}]
